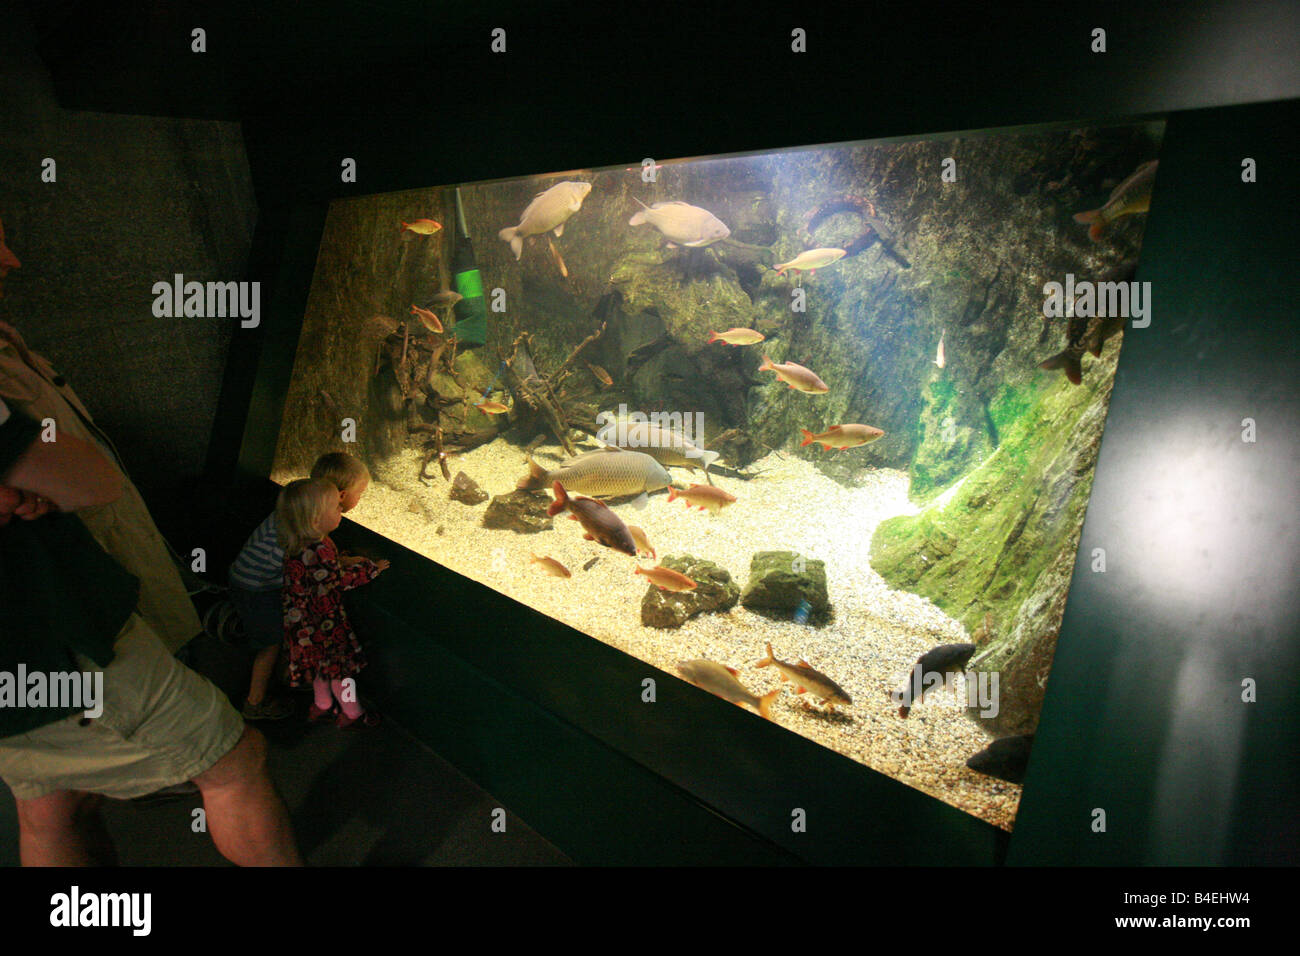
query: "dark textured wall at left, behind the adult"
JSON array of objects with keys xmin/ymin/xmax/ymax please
[{"xmin": 0, "ymin": 10, "xmax": 257, "ymax": 515}]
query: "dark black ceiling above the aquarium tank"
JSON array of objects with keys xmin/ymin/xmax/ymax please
[{"xmin": 30, "ymin": 0, "xmax": 1300, "ymax": 202}]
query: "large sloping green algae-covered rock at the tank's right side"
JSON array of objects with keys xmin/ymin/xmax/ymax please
[{"xmin": 871, "ymin": 356, "xmax": 1118, "ymax": 735}]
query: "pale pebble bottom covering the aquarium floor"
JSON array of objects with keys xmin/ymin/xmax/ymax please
[{"xmin": 274, "ymin": 440, "xmax": 1021, "ymax": 830}]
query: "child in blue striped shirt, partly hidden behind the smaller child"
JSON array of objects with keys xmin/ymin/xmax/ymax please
[{"xmin": 230, "ymin": 451, "xmax": 371, "ymax": 721}]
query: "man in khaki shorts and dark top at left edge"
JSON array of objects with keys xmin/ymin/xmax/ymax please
[{"xmin": 0, "ymin": 217, "xmax": 302, "ymax": 865}]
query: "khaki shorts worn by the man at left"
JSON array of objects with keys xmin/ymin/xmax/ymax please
[{"xmin": 0, "ymin": 614, "xmax": 244, "ymax": 800}]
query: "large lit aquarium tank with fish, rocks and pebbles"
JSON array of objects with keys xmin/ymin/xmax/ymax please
[{"xmin": 272, "ymin": 122, "xmax": 1164, "ymax": 830}]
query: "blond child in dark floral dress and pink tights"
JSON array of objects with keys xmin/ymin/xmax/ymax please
[{"xmin": 276, "ymin": 479, "xmax": 389, "ymax": 727}]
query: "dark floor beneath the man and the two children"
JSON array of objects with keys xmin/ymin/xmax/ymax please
[{"xmin": 0, "ymin": 637, "xmax": 572, "ymax": 866}]
